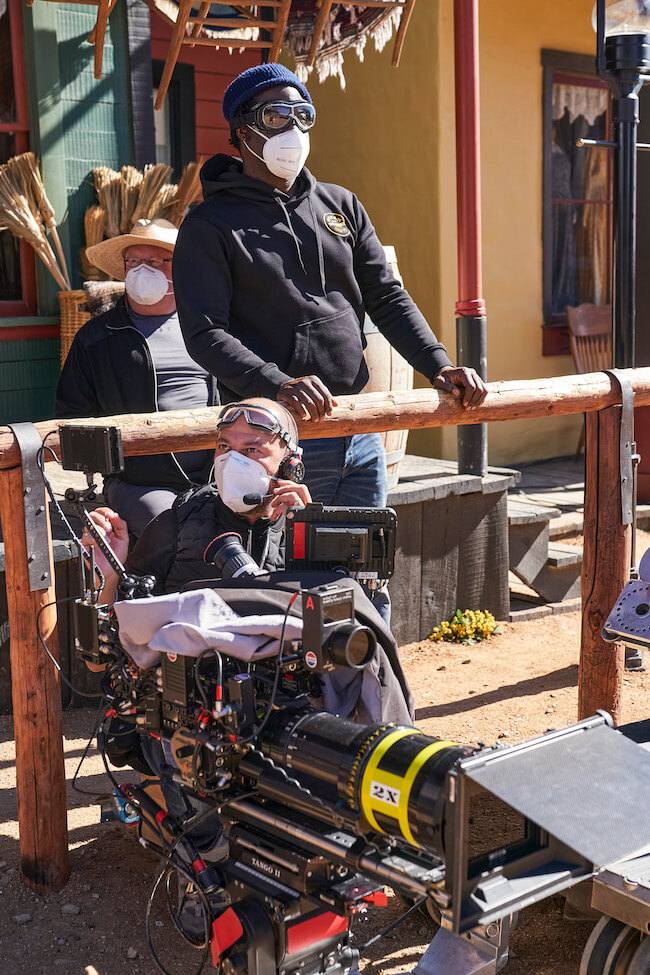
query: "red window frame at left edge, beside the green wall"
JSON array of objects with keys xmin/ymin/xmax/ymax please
[{"xmin": 0, "ymin": 0, "xmax": 37, "ymax": 318}]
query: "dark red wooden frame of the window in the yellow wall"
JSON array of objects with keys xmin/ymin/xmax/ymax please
[{"xmin": 541, "ymin": 49, "xmax": 608, "ymax": 356}]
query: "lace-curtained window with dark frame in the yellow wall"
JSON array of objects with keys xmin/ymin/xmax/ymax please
[{"xmin": 543, "ymin": 52, "xmax": 612, "ymax": 354}]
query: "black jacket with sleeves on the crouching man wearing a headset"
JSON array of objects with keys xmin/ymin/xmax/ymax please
[{"xmin": 126, "ymin": 484, "xmax": 284, "ymax": 596}]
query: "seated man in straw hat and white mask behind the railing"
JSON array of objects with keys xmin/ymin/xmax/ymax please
[{"xmin": 56, "ymin": 219, "xmax": 217, "ymax": 536}]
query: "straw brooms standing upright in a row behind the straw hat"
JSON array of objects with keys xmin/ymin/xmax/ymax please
[{"xmin": 81, "ymin": 161, "xmax": 201, "ymax": 281}]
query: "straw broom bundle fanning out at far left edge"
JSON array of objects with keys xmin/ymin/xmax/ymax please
[{"xmin": 0, "ymin": 152, "xmax": 70, "ymax": 291}]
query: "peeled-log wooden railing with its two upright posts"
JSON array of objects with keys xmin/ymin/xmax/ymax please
[{"xmin": 0, "ymin": 369, "xmax": 650, "ymax": 891}]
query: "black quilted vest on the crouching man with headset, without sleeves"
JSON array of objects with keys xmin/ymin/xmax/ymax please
[{"xmin": 165, "ymin": 484, "xmax": 284, "ymax": 592}]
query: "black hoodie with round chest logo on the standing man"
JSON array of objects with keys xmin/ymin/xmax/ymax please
[{"xmin": 173, "ymin": 155, "xmax": 450, "ymax": 400}]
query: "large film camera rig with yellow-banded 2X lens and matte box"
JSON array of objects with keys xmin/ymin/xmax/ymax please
[{"xmin": 59, "ymin": 426, "xmax": 650, "ymax": 975}]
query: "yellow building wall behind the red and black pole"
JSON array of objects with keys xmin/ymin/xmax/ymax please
[{"xmin": 278, "ymin": 0, "xmax": 595, "ymax": 465}]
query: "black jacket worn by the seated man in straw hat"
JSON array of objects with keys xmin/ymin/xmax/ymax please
[{"xmin": 55, "ymin": 298, "xmax": 218, "ymax": 491}]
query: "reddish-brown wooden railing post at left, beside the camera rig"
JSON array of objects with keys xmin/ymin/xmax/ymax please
[{"xmin": 0, "ymin": 467, "xmax": 70, "ymax": 892}]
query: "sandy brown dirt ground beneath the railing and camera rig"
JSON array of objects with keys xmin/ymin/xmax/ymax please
[{"xmin": 0, "ymin": 613, "xmax": 650, "ymax": 975}]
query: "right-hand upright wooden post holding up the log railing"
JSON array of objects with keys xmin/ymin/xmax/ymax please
[{"xmin": 578, "ymin": 406, "xmax": 632, "ymax": 724}]
